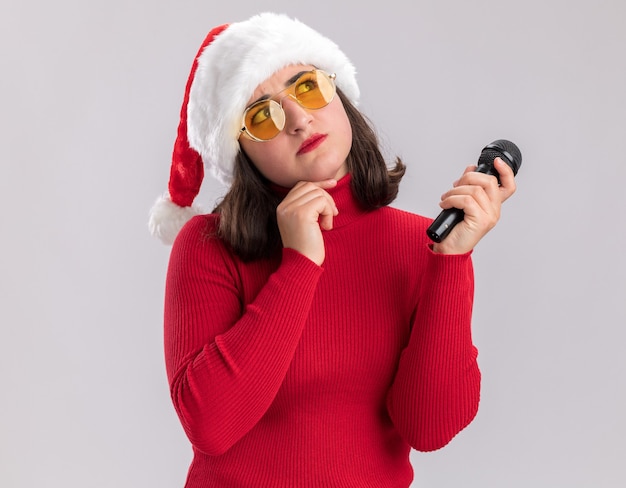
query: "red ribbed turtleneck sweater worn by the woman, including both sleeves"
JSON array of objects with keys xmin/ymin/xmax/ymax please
[{"xmin": 165, "ymin": 176, "xmax": 480, "ymax": 488}]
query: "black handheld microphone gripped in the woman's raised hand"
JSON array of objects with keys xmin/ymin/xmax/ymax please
[{"xmin": 426, "ymin": 139, "xmax": 522, "ymax": 242}]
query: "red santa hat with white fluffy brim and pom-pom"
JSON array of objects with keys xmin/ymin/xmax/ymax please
[{"xmin": 149, "ymin": 13, "xmax": 359, "ymax": 244}]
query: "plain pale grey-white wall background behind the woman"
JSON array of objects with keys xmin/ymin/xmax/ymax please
[{"xmin": 0, "ymin": 0, "xmax": 626, "ymax": 488}]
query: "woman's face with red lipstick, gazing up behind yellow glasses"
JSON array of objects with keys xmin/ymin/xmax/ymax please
[{"xmin": 239, "ymin": 65, "xmax": 352, "ymax": 188}]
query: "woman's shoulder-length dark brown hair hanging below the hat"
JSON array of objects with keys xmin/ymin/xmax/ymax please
[{"xmin": 213, "ymin": 89, "xmax": 406, "ymax": 261}]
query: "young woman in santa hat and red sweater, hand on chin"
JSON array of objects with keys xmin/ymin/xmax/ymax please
[{"xmin": 150, "ymin": 13, "xmax": 515, "ymax": 488}]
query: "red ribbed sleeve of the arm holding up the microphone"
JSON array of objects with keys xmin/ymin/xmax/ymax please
[{"xmin": 387, "ymin": 250, "xmax": 480, "ymax": 451}]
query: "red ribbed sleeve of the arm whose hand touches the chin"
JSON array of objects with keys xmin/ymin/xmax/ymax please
[{"xmin": 164, "ymin": 218, "xmax": 322, "ymax": 455}]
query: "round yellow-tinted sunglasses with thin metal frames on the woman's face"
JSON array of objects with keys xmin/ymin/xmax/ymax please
[{"xmin": 243, "ymin": 70, "xmax": 335, "ymax": 141}]
